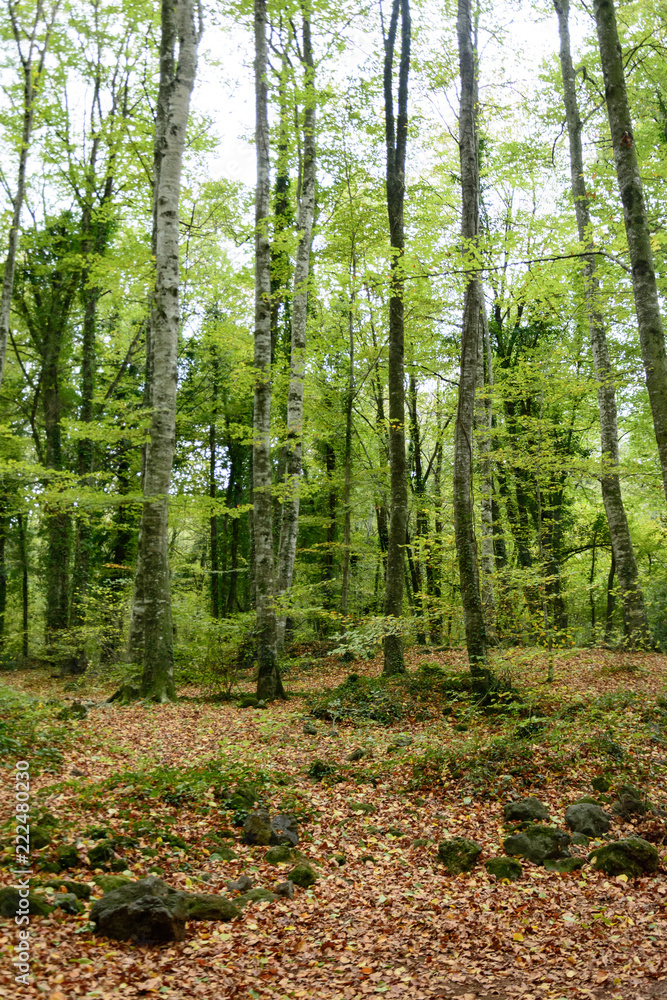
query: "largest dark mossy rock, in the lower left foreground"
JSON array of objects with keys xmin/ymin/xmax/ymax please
[{"xmin": 90, "ymin": 878, "xmax": 187, "ymax": 943}]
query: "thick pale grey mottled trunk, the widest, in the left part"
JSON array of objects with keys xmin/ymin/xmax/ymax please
[{"xmin": 133, "ymin": 0, "xmax": 201, "ymax": 702}]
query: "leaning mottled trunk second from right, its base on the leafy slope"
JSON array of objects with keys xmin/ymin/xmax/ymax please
[{"xmin": 554, "ymin": 0, "xmax": 650, "ymax": 646}]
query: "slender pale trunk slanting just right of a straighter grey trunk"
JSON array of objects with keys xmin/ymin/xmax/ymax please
[{"xmin": 276, "ymin": 15, "xmax": 316, "ymax": 651}]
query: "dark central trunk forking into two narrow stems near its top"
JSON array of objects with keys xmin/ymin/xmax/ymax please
[{"xmin": 383, "ymin": 0, "xmax": 411, "ymax": 675}]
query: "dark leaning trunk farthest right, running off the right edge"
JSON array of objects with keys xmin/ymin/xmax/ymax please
[{"xmin": 593, "ymin": 0, "xmax": 667, "ymax": 500}]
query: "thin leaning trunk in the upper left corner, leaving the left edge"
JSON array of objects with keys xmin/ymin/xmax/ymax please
[{"xmin": 0, "ymin": 0, "xmax": 60, "ymax": 384}]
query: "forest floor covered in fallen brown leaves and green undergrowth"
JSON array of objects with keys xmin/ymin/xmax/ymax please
[{"xmin": 0, "ymin": 648, "xmax": 667, "ymax": 1000}]
